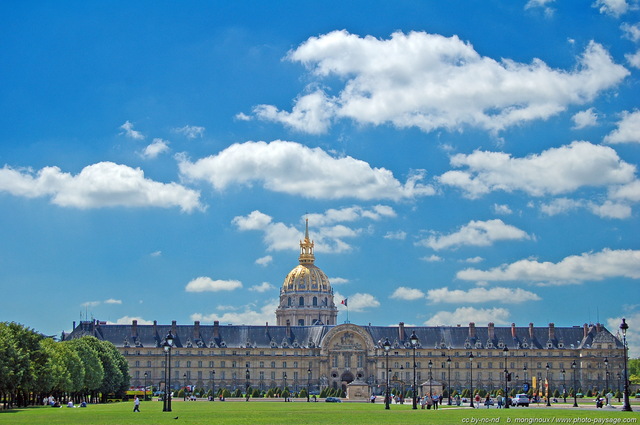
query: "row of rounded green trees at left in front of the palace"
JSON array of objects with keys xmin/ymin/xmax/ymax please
[{"xmin": 0, "ymin": 322, "xmax": 130, "ymax": 409}]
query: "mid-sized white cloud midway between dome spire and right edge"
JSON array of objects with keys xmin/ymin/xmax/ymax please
[{"xmin": 416, "ymin": 219, "xmax": 531, "ymax": 251}]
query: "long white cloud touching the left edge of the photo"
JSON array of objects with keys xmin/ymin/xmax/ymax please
[{"xmin": 0, "ymin": 162, "xmax": 203, "ymax": 212}]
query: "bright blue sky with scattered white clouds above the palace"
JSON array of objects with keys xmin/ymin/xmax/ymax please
[{"xmin": 0, "ymin": 0, "xmax": 640, "ymax": 353}]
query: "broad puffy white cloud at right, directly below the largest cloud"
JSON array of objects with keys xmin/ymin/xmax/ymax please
[{"xmin": 438, "ymin": 141, "xmax": 636, "ymax": 198}]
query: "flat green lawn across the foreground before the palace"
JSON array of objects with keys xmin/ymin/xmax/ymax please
[{"xmin": 0, "ymin": 401, "xmax": 640, "ymax": 425}]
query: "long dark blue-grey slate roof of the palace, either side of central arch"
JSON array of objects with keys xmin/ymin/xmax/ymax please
[{"xmin": 64, "ymin": 322, "xmax": 622, "ymax": 350}]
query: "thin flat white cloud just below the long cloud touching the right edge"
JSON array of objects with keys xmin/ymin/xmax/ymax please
[{"xmin": 427, "ymin": 286, "xmax": 542, "ymax": 304}]
